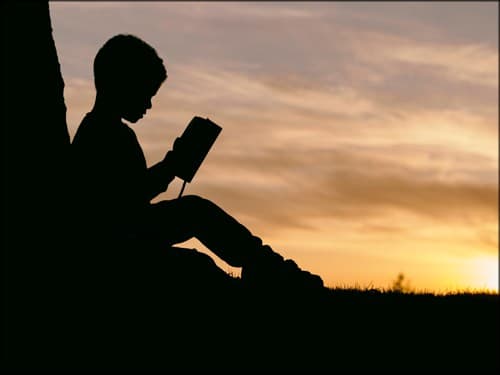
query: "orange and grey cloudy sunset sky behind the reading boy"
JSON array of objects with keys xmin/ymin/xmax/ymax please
[{"xmin": 50, "ymin": 2, "xmax": 499, "ymax": 292}]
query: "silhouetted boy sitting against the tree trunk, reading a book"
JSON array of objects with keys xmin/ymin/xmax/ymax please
[{"xmin": 72, "ymin": 35, "xmax": 323, "ymax": 289}]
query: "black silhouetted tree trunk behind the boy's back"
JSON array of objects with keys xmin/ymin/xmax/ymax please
[{"xmin": 1, "ymin": 1, "xmax": 70, "ymax": 369}]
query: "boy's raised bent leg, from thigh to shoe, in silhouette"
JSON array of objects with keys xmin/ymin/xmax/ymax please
[{"xmin": 148, "ymin": 195, "xmax": 323, "ymax": 288}]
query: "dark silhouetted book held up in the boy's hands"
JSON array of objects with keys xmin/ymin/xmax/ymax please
[{"xmin": 175, "ymin": 116, "xmax": 222, "ymax": 182}]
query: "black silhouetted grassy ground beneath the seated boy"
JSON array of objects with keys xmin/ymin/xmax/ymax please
[{"xmin": 2, "ymin": 272, "xmax": 500, "ymax": 374}]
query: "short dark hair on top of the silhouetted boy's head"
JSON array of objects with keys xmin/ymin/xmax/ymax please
[{"xmin": 94, "ymin": 34, "xmax": 167, "ymax": 92}]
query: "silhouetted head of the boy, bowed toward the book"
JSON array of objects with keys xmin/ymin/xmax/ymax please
[{"xmin": 94, "ymin": 34, "xmax": 167, "ymax": 122}]
